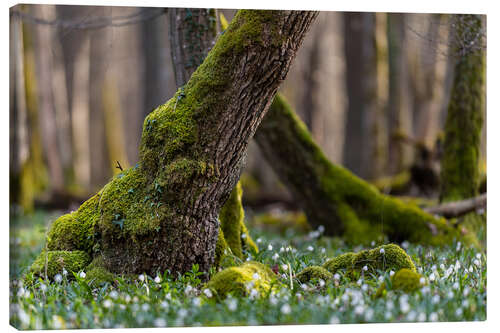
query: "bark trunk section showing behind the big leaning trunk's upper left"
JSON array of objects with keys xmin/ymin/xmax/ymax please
[{"xmin": 168, "ymin": 8, "xmax": 217, "ymax": 86}]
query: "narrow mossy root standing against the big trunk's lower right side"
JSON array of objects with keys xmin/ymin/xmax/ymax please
[{"xmin": 219, "ymin": 182, "xmax": 258, "ymax": 259}]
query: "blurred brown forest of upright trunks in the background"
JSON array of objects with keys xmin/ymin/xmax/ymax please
[{"xmin": 10, "ymin": 5, "xmax": 486, "ymax": 218}]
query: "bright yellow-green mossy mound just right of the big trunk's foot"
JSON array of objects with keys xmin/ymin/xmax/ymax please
[{"xmin": 207, "ymin": 261, "xmax": 278, "ymax": 298}]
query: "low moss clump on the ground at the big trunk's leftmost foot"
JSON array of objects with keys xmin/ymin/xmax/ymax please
[{"xmin": 30, "ymin": 251, "xmax": 91, "ymax": 279}]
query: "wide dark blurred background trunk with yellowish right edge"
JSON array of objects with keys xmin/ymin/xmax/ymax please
[{"xmin": 344, "ymin": 13, "xmax": 387, "ymax": 178}]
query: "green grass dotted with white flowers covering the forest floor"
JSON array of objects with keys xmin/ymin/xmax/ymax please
[{"xmin": 10, "ymin": 212, "xmax": 486, "ymax": 329}]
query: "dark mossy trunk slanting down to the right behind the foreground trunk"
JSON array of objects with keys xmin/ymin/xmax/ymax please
[{"xmin": 255, "ymin": 95, "xmax": 459, "ymax": 244}]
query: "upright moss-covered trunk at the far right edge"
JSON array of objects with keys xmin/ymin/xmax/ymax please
[{"xmin": 440, "ymin": 15, "xmax": 485, "ymax": 202}]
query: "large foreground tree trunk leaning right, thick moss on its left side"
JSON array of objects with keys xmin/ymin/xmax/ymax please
[{"xmin": 31, "ymin": 10, "xmax": 317, "ymax": 274}]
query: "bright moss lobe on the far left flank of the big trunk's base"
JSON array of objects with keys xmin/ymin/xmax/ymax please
[{"xmin": 47, "ymin": 194, "xmax": 100, "ymax": 253}]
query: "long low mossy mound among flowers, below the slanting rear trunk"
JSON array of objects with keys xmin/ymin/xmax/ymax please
[{"xmin": 323, "ymin": 244, "xmax": 417, "ymax": 274}]
